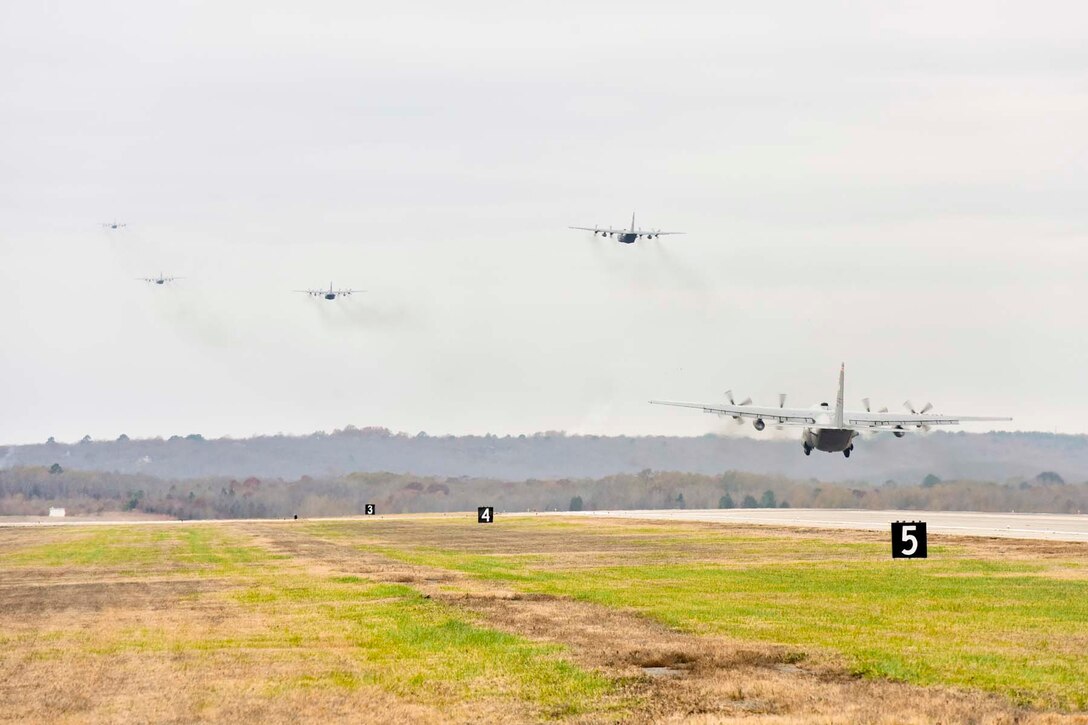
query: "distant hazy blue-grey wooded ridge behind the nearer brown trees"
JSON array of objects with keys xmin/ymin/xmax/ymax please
[{"xmin": 0, "ymin": 422, "xmax": 1088, "ymax": 483}]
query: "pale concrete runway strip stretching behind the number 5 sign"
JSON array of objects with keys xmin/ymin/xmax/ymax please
[{"xmin": 530, "ymin": 508, "xmax": 1088, "ymax": 541}]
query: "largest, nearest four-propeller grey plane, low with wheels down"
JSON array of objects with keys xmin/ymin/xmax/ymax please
[{"xmin": 651, "ymin": 366, "xmax": 1012, "ymax": 458}]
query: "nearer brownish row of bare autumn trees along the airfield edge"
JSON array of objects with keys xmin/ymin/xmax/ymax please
[{"xmin": 0, "ymin": 465, "xmax": 1088, "ymax": 519}]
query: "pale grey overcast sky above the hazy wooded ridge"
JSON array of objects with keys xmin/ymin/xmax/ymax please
[{"xmin": 0, "ymin": 0, "xmax": 1088, "ymax": 443}]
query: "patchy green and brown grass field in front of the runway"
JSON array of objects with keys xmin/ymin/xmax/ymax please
[{"xmin": 0, "ymin": 516, "xmax": 1088, "ymax": 723}]
